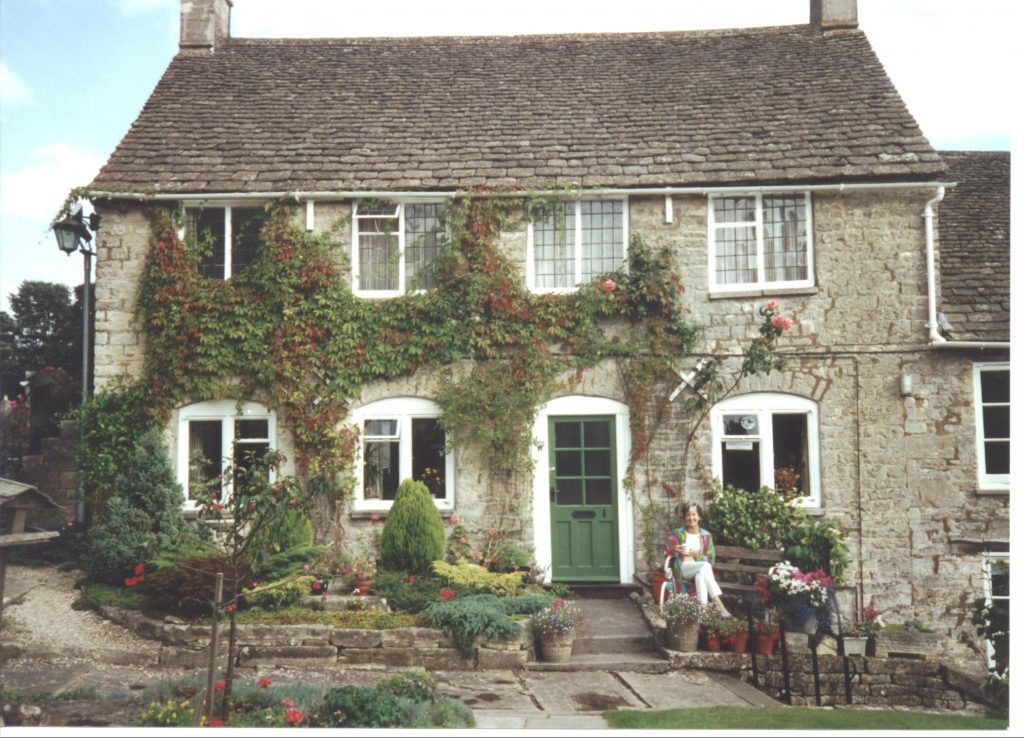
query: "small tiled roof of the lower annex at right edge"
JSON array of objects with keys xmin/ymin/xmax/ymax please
[{"xmin": 938, "ymin": 151, "xmax": 1010, "ymax": 341}]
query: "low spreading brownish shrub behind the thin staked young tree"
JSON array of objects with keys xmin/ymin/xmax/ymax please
[{"xmin": 141, "ymin": 554, "xmax": 250, "ymax": 617}]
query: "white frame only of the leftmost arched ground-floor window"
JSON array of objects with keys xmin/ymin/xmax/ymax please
[{"xmin": 175, "ymin": 400, "xmax": 278, "ymax": 510}]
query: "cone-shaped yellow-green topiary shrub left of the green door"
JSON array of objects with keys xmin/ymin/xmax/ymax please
[{"xmin": 380, "ymin": 479, "xmax": 444, "ymax": 573}]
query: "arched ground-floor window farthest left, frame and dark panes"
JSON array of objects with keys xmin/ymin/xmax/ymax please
[{"xmin": 177, "ymin": 400, "xmax": 275, "ymax": 509}]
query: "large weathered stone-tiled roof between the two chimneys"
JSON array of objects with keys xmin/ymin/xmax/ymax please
[{"xmin": 92, "ymin": 26, "xmax": 944, "ymax": 192}]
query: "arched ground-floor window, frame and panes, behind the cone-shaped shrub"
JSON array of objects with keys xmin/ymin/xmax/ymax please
[{"xmin": 354, "ymin": 397, "xmax": 455, "ymax": 510}]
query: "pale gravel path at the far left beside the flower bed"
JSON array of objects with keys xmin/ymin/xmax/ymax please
[{"xmin": 0, "ymin": 566, "xmax": 158, "ymax": 665}]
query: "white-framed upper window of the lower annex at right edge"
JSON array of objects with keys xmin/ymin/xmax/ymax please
[{"xmin": 974, "ymin": 363, "xmax": 1010, "ymax": 489}]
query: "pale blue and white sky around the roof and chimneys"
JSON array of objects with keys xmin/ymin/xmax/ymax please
[{"xmin": 0, "ymin": 0, "xmax": 1024, "ymax": 309}]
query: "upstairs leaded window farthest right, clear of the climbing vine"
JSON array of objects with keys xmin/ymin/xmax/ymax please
[{"xmin": 709, "ymin": 192, "xmax": 814, "ymax": 292}]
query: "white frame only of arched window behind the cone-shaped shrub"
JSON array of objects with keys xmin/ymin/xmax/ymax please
[{"xmin": 351, "ymin": 397, "xmax": 455, "ymax": 512}]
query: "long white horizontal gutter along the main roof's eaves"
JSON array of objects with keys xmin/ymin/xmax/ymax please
[{"xmin": 86, "ymin": 182, "xmax": 955, "ymax": 202}]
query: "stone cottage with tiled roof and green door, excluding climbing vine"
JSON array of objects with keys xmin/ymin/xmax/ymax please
[{"xmin": 81, "ymin": 0, "xmax": 1010, "ymax": 663}]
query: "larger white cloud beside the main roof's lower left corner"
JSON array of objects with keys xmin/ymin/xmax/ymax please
[{"xmin": 0, "ymin": 143, "xmax": 105, "ymax": 220}]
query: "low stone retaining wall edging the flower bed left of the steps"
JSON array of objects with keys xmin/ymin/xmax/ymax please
[{"xmin": 100, "ymin": 598, "xmax": 534, "ymax": 670}]
